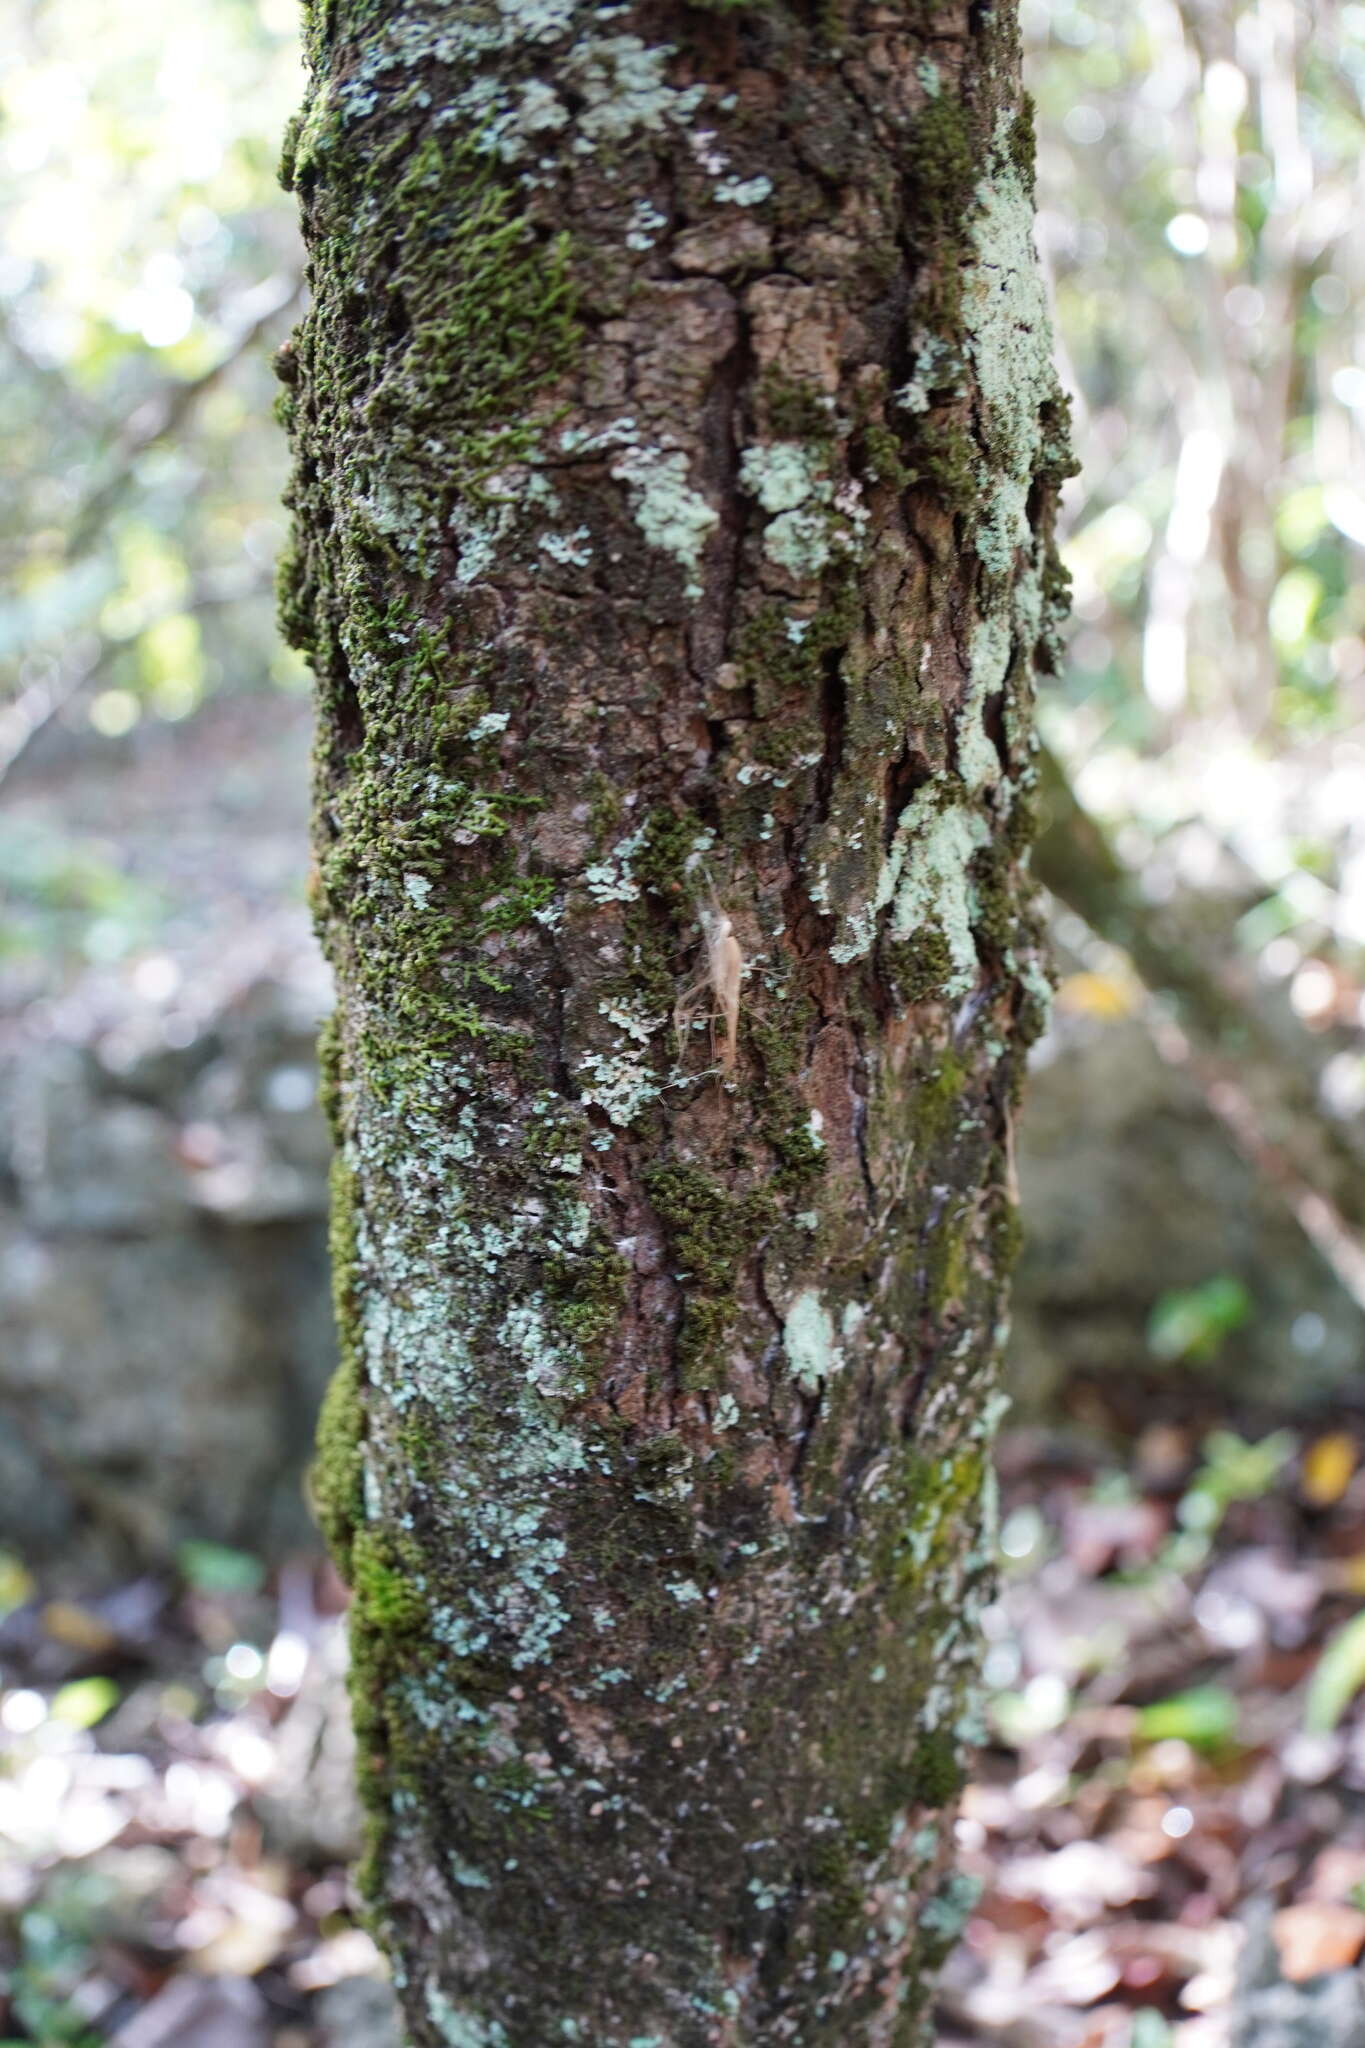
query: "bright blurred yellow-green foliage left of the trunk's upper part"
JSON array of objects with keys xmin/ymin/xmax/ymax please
[{"xmin": 0, "ymin": 0, "xmax": 301, "ymax": 757}]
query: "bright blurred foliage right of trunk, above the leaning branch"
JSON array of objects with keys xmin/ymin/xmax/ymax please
[{"xmin": 1023, "ymin": 0, "xmax": 1365, "ymax": 995}]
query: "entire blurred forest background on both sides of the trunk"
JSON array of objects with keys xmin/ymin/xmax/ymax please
[{"xmin": 0, "ymin": 0, "xmax": 1365, "ymax": 2048}]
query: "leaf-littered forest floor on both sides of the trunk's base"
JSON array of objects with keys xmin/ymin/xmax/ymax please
[{"xmin": 0, "ymin": 1423, "xmax": 1365, "ymax": 2048}]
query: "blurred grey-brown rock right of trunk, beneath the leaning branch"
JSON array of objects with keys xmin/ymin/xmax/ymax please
[{"xmin": 1011, "ymin": 1006, "xmax": 1365, "ymax": 1413}]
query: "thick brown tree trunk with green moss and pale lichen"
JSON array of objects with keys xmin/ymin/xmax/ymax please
[{"xmin": 280, "ymin": 0, "xmax": 1066, "ymax": 2048}]
